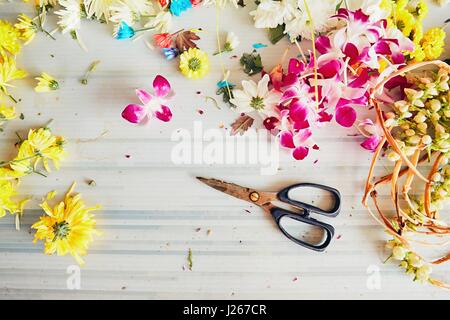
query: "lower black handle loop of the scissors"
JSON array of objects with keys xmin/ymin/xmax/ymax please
[{"xmin": 270, "ymin": 207, "xmax": 334, "ymax": 252}]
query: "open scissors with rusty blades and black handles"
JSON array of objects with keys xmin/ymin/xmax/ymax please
[{"xmin": 197, "ymin": 177, "xmax": 341, "ymax": 251}]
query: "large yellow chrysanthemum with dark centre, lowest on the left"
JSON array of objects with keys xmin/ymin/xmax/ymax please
[{"xmin": 31, "ymin": 183, "xmax": 100, "ymax": 265}]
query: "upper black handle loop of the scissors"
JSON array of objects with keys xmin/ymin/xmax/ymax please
[{"xmin": 277, "ymin": 183, "xmax": 341, "ymax": 217}]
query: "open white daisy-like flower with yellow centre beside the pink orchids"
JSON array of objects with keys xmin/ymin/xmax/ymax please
[{"xmin": 230, "ymin": 74, "xmax": 281, "ymax": 120}]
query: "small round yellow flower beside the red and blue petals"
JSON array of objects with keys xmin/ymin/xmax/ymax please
[{"xmin": 180, "ymin": 48, "xmax": 209, "ymax": 79}]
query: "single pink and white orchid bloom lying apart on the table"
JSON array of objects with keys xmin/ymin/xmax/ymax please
[{"xmin": 122, "ymin": 75, "xmax": 172, "ymax": 123}]
